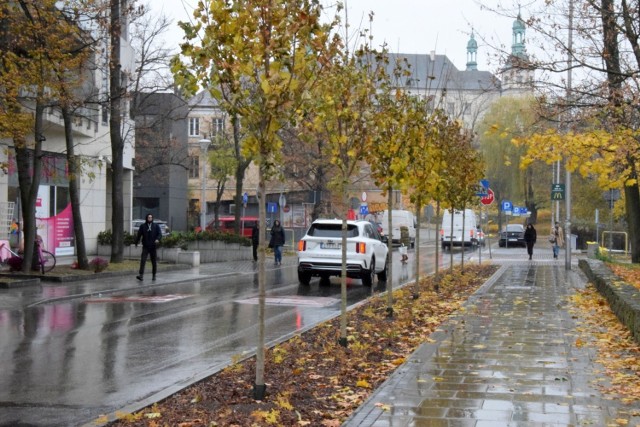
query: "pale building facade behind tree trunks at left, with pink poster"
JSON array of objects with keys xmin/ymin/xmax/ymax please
[{"xmin": 0, "ymin": 2, "xmax": 135, "ymax": 256}]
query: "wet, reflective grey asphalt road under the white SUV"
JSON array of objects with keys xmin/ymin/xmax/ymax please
[{"xmin": 0, "ymin": 243, "xmax": 487, "ymax": 426}]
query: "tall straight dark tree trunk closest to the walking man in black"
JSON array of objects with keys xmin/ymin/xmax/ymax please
[{"xmin": 109, "ymin": 0, "xmax": 124, "ymax": 263}]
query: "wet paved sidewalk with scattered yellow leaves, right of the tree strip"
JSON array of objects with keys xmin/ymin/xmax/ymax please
[{"xmin": 344, "ymin": 260, "xmax": 637, "ymax": 427}]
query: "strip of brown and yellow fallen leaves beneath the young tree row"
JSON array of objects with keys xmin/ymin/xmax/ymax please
[{"xmin": 111, "ymin": 264, "xmax": 498, "ymax": 427}]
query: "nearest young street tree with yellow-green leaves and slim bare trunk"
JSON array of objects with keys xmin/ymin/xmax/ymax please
[{"xmin": 172, "ymin": 0, "xmax": 338, "ymax": 399}]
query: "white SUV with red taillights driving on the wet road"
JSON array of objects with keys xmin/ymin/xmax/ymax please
[{"xmin": 298, "ymin": 219, "xmax": 388, "ymax": 286}]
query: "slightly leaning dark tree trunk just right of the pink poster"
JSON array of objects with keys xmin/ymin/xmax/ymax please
[{"xmin": 62, "ymin": 107, "xmax": 89, "ymax": 270}]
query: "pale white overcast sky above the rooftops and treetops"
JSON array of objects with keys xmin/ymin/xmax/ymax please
[{"xmin": 151, "ymin": 0, "xmax": 526, "ymax": 71}]
